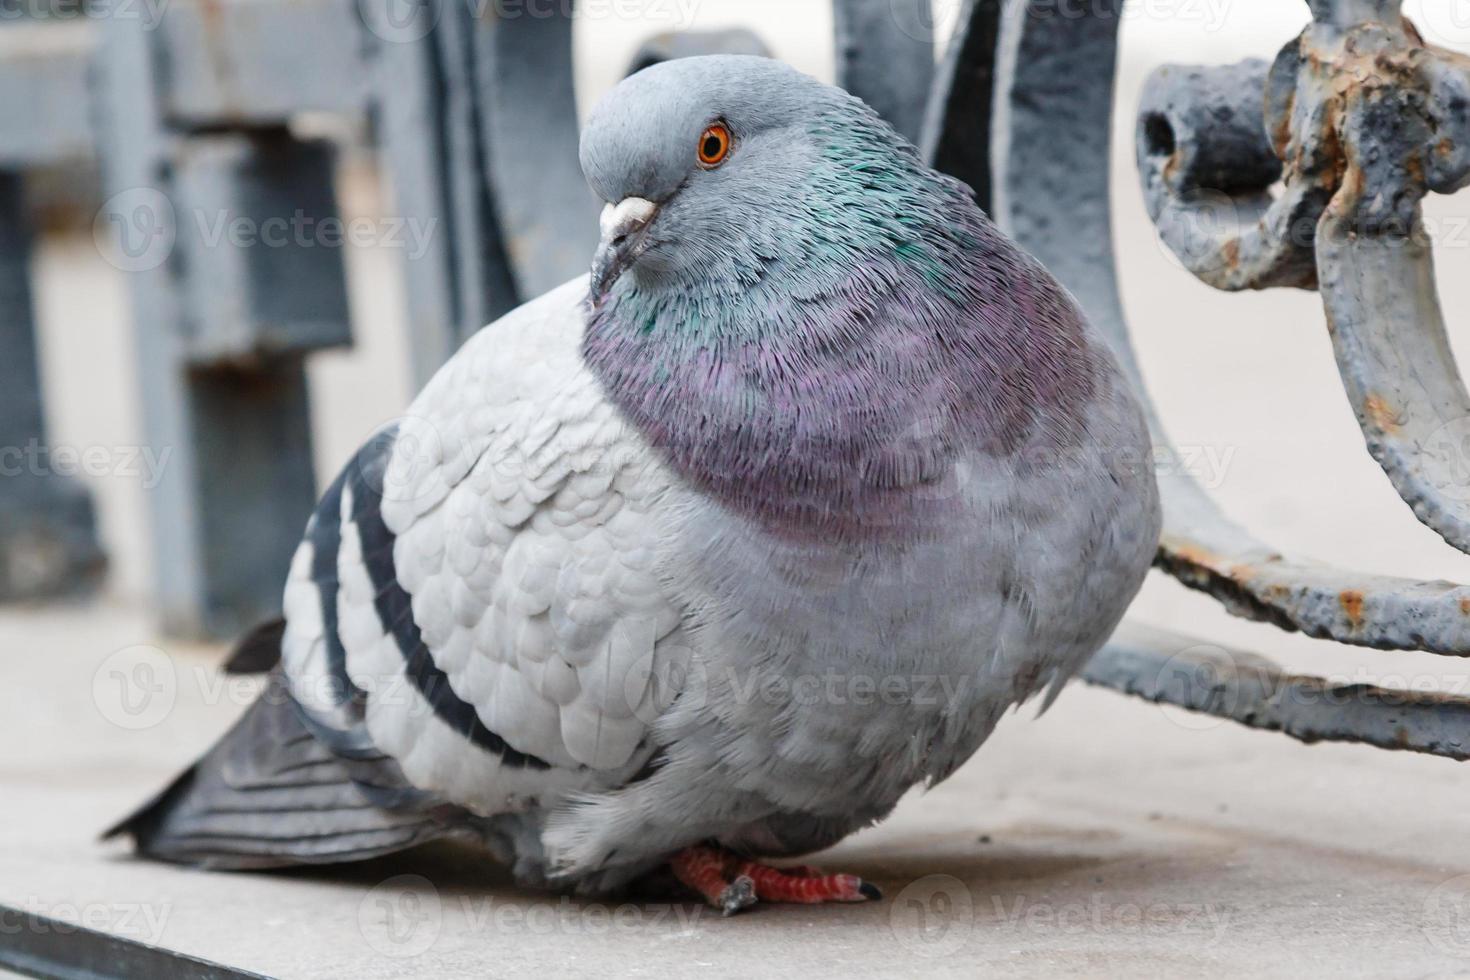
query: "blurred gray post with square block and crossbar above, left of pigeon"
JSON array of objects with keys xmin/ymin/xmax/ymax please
[{"xmin": 94, "ymin": 17, "xmax": 360, "ymax": 635}]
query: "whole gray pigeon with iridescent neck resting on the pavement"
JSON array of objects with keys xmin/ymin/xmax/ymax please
[{"xmin": 113, "ymin": 56, "xmax": 1160, "ymax": 912}]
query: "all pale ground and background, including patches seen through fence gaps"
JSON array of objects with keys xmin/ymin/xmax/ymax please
[{"xmin": 0, "ymin": 0, "xmax": 1470, "ymax": 979}]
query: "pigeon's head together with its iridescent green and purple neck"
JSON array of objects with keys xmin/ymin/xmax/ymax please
[{"xmin": 581, "ymin": 56, "xmax": 1092, "ymax": 539}]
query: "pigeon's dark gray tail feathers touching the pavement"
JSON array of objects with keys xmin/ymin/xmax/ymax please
[{"xmin": 103, "ymin": 676, "xmax": 454, "ymax": 870}]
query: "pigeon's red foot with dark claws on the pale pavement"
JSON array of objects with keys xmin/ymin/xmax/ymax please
[{"xmin": 669, "ymin": 846, "xmax": 882, "ymax": 915}]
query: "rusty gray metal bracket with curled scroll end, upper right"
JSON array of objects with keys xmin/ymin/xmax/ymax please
[{"xmin": 1138, "ymin": 0, "xmax": 1470, "ymax": 551}]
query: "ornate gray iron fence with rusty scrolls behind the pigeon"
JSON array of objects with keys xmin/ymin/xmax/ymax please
[{"xmin": 0, "ymin": 0, "xmax": 1470, "ymax": 758}]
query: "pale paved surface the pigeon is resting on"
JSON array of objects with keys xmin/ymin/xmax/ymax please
[{"xmin": 0, "ymin": 610, "xmax": 1470, "ymax": 980}]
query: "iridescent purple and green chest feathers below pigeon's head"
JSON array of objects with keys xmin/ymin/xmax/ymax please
[{"xmin": 582, "ymin": 253, "xmax": 1095, "ymax": 539}]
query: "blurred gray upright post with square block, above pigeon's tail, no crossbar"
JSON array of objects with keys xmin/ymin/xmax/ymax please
[{"xmin": 94, "ymin": 21, "xmax": 345, "ymax": 635}]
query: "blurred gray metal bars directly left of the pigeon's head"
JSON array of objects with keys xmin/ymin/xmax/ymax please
[{"xmin": 362, "ymin": 0, "xmax": 597, "ymax": 383}]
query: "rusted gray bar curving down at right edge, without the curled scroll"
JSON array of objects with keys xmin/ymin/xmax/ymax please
[{"xmin": 1297, "ymin": 11, "xmax": 1470, "ymax": 551}]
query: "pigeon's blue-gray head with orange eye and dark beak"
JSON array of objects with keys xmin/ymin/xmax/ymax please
[{"xmin": 581, "ymin": 56, "xmax": 917, "ymax": 298}]
